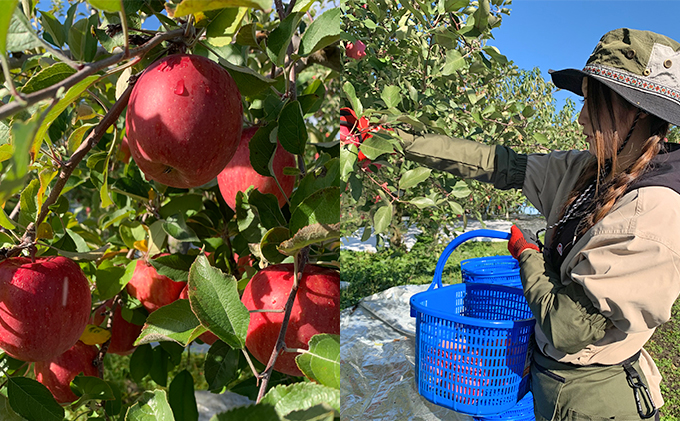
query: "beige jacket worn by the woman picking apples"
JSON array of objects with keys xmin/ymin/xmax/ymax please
[{"xmin": 523, "ymin": 151, "xmax": 680, "ymax": 407}]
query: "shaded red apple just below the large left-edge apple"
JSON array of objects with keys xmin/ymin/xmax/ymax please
[{"xmin": 34, "ymin": 341, "xmax": 99, "ymax": 403}]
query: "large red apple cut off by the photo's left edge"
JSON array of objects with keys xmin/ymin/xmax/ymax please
[{"xmin": 0, "ymin": 256, "xmax": 92, "ymax": 361}]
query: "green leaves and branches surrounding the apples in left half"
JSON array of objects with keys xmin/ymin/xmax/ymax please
[{"xmin": 0, "ymin": 0, "xmax": 342, "ymax": 420}]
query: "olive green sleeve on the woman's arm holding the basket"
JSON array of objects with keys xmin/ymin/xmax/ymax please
[{"xmin": 519, "ymin": 250, "xmax": 611, "ymax": 354}]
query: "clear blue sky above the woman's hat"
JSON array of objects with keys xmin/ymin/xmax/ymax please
[{"xmin": 488, "ymin": 0, "xmax": 680, "ymax": 106}]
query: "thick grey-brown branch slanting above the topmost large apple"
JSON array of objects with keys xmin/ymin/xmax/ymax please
[{"xmin": 0, "ymin": 29, "xmax": 184, "ymax": 120}]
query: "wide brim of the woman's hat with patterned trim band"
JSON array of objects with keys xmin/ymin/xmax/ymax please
[{"xmin": 548, "ymin": 69, "xmax": 680, "ymax": 126}]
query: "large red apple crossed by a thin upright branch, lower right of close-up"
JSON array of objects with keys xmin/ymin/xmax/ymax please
[{"xmin": 241, "ymin": 264, "xmax": 340, "ymax": 376}]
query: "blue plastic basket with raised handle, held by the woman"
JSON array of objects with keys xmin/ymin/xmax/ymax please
[{"xmin": 410, "ymin": 230, "xmax": 535, "ymax": 415}]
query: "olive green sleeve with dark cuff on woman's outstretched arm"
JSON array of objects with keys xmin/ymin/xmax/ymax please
[{"xmin": 397, "ymin": 130, "xmax": 527, "ymax": 190}]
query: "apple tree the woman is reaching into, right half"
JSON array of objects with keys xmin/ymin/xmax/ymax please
[{"xmin": 341, "ymin": 0, "xmax": 580, "ymax": 247}]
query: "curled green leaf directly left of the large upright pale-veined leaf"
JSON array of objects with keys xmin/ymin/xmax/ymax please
[{"xmin": 135, "ymin": 300, "xmax": 206, "ymax": 346}]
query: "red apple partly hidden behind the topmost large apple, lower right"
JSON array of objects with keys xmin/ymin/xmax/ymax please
[{"xmin": 217, "ymin": 127, "xmax": 296, "ymax": 209}]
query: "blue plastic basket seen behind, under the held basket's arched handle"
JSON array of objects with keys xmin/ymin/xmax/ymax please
[{"xmin": 460, "ymin": 256, "xmax": 522, "ymax": 288}]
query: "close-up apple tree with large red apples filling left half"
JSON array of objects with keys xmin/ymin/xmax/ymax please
[{"xmin": 0, "ymin": 0, "xmax": 342, "ymax": 421}]
